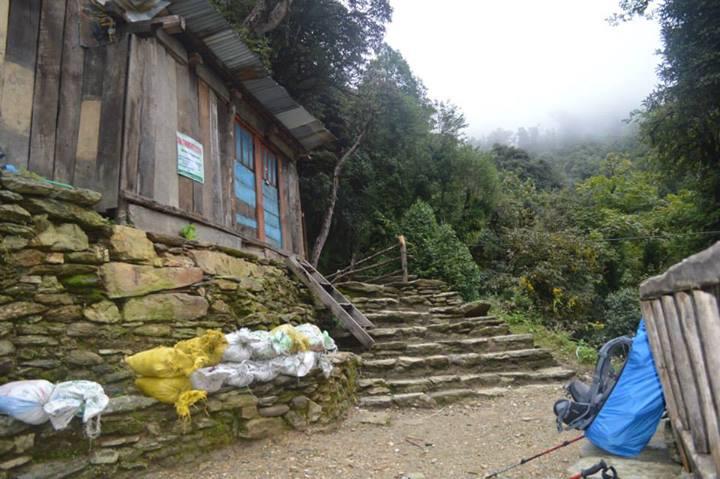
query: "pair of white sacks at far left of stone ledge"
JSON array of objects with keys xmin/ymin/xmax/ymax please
[{"xmin": 0, "ymin": 379, "xmax": 110, "ymax": 439}]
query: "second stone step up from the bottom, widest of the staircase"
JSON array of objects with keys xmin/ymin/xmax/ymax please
[{"xmin": 358, "ymin": 366, "xmax": 575, "ymax": 397}]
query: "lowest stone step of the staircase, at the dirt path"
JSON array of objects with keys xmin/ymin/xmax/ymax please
[{"xmin": 358, "ymin": 388, "xmax": 505, "ymax": 408}]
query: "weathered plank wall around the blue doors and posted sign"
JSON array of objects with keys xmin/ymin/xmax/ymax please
[{"xmin": 121, "ymin": 36, "xmax": 303, "ymax": 253}]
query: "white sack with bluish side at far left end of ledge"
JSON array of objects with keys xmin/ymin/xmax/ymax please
[{"xmin": 0, "ymin": 379, "xmax": 55, "ymax": 425}]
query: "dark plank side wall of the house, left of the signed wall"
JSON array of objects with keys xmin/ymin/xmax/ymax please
[{"xmin": 0, "ymin": 0, "xmax": 128, "ymax": 210}]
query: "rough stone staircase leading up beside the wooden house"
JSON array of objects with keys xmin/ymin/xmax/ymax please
[{"xmin": 339, "ymin": 279, "xmax": 574, "ymax": 407}]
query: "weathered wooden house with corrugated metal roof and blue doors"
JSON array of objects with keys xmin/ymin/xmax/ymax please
[{"xmin": 0, "ymin": 0, "xmax": 332, "ymax": 254}]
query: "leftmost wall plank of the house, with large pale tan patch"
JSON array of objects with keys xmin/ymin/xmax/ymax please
[{"xmin": 0, "ymin": 0, "xmax": 41, "ymax": 168}]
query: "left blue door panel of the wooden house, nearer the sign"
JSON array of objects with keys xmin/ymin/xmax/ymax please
[{"xmin": 233, "ymin": 124, "xmax": 257, "ymax": 237}]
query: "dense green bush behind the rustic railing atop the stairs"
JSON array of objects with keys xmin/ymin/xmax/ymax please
[{"xmin": 401, "ymin": 201, "xmax": 481, "ymax": 301}]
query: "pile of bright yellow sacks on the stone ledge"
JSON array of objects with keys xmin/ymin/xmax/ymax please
[{"xmin": 125, "ymin": 331, "xmax": 228, "ymax": 418}]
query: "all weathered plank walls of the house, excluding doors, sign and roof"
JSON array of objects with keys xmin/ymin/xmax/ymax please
[{"xmin": 0, "ymin": 0, "xmax": 303, "ymax": 253}]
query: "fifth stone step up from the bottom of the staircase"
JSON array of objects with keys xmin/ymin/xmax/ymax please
[{"xmin": 368, "ymin": 318, "xmax": 510, "ymax": 343}]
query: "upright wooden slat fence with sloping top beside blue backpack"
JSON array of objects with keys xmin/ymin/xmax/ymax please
[{"xmin": 640, "ymin": 242, "xmax": 720, "ymax": 479}]
